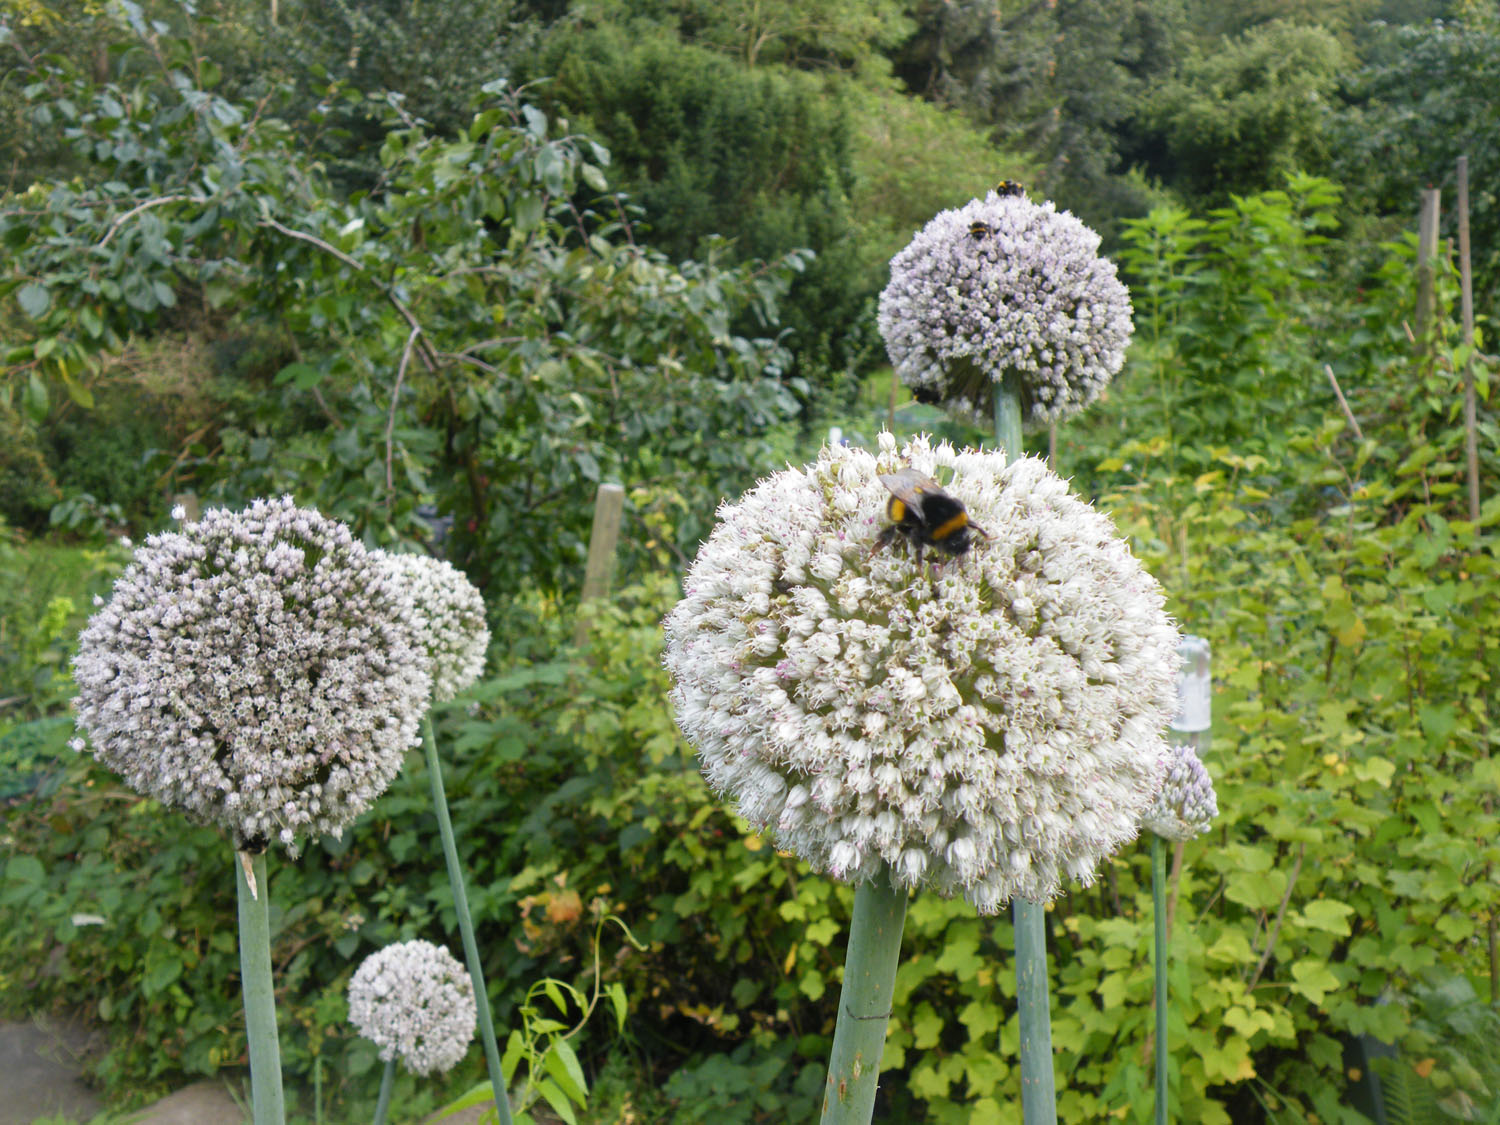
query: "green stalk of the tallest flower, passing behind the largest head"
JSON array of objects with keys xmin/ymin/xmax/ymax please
[{"xmin": 995, "ymin": 372, "xmax": 1058, "ymax": 1125}]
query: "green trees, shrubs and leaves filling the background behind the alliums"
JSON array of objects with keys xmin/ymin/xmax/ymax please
[{"xmin": 0, "ymin": 0, "xmax": 1500, "ymax": 1125}]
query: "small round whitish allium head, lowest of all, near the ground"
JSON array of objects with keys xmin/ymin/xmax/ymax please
[{"xmin": 350, "ymin": 941, "xmax": 479, "ymax": 1074}]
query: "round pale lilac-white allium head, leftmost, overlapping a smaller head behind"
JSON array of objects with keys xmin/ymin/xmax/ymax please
[{"xmin": 74, "ymin": 497, "xmax": 431, "ymax": 855}]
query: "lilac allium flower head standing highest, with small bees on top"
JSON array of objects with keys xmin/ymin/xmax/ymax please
[{"xmin": 879, "ymin": 192, "xmax": 1133, "ymax": 426}]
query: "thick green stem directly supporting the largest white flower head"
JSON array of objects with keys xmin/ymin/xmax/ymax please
[{"xmin": 822, "ymin": 870, "xmax": 906, "ymax": 1125}]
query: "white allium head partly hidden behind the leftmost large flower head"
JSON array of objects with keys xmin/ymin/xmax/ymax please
[{"xmin": 377, "ymin": 552, "xmax": 489, "ymax": 704}]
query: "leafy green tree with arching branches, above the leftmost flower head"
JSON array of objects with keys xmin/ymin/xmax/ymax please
[{"xmin": 0, "ymin": 19, "xmax": 804, "ymax": 584}]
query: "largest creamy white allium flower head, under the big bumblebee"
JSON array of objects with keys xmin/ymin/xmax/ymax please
[{"xmin": 665, "ymin": 434, "xmax": 1178, "ymax": 914}]
